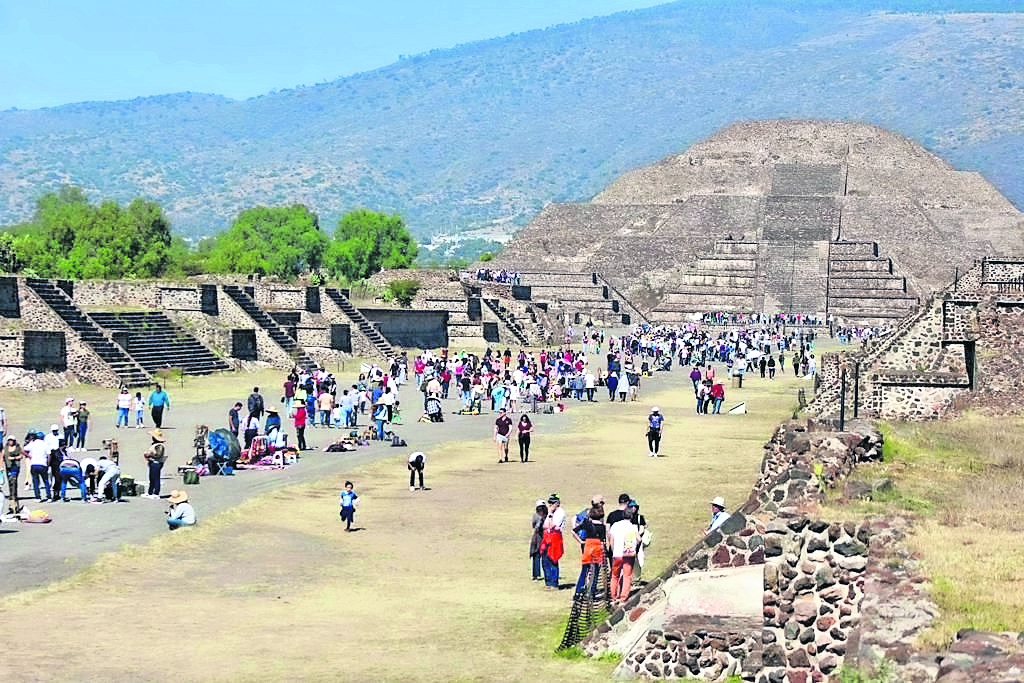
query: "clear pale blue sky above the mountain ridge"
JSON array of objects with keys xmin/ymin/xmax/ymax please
[{"xmin": 0, "ymin": 0, "xmax": 666, "ymax": 110}]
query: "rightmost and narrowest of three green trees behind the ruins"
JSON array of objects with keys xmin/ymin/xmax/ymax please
[{"xmin": 326, "ymin": 209, "xmax": 419, "ymax": 281}]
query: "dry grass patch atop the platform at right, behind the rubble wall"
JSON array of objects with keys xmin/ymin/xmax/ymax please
[{"xmin": 823, "ymin": 415, "xmax": 1024, "ymax": 647}]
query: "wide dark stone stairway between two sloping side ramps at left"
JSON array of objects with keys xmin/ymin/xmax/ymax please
[{"xmin": 89, "ymin": 311, "xmax": 230, "ymax": 375}]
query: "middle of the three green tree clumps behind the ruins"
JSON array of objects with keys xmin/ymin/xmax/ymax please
[{"xmin": 204, "ymin": 205, "xmax": 328, "ymax": 280}]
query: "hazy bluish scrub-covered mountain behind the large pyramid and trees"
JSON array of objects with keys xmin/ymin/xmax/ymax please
[{"xmin": 0, "ymin": 0, "xmax": 1024, "ymax": 239}]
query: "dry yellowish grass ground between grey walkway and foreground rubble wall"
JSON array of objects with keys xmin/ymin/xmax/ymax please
[{"xmin": 0, "ymin": 360, "xmax": 804, "ymax": 683}]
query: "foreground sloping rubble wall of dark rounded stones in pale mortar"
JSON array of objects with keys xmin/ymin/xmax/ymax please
[{"xmin": 583, "ymin": 423, "xmax": 882, "ymax": 683}]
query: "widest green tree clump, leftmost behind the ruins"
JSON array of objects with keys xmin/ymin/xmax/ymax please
[{"xmin": 10, "ymin": 187, "xmax": 171, "ymax": 279}]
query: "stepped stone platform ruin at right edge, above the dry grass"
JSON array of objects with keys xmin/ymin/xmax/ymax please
[{"xmin": 809, "ymin": 258, "xmax": 1024, "ymax": 420}]
